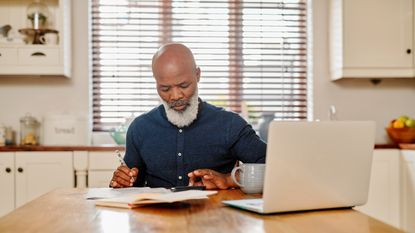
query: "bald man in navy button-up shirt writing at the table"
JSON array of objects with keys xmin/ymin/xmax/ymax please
[{"xmin": 110, "ymin": 43, "xmax": 266, "ymax": 189}]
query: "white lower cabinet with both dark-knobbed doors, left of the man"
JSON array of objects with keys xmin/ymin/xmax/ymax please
[{"xmin": 0, "ymin": 151, "xmax": 74, "ymax": 215}]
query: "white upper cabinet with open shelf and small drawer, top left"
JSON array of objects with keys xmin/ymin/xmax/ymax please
[{"xmin": 0, "ymin": 0, "xmax": 71, "ymax": 77}]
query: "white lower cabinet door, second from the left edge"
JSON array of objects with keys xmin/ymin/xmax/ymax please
[{"xmin": 16, "ymin": 151, "xmax": 74, "ymax": 207}]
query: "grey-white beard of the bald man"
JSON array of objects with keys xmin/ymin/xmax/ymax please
[{"xmin": 160, "ymin": 89, "xmax": 199, "ymax": 128}]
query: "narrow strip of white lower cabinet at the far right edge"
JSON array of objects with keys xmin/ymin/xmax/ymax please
[{"xmin": 402, "ymin": 150, "xmax": 415, "ymax": 232}]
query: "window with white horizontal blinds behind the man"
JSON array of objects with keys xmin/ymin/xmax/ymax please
[{"xmin": 92, "ymin": 0, "xmax": 310, "ymax": 131}]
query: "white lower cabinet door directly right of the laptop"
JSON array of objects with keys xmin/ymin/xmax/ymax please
[{"xmin": 356, "ymin": 149, "xmax": 400, "ymax": 228}]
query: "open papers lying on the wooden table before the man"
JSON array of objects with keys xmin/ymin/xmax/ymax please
[{"xmin": 95, "ymin": 190, "xmax": 217, "ymax": 208}]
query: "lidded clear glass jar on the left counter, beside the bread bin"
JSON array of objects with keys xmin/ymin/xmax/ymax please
[{"xmin": 20, "ymin": 114, "xmax": 40, "ymax": 145}]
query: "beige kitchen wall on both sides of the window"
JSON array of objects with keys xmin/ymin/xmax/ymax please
[{"xmin": 0, "ymin": 0, "xmax": 415, "ymax": 143}]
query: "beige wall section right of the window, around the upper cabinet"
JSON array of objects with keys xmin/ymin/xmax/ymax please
[{"xmin": 313, "ymin": 0, "xmax": 415, "ymax": 143}]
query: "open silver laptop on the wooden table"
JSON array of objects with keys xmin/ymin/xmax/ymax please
[{"xmin": 222, "ymin": 121, "xmax": 375, "ymax": 214}]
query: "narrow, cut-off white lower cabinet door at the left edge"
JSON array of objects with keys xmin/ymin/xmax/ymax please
[{"xmin": 0, "ymin": 152, "xmax": 15, "ymax": 217}]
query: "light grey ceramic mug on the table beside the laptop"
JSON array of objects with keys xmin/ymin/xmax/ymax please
[{"xmin": 231, "ymin": 163, "xmax": 265, "ymax": 193}]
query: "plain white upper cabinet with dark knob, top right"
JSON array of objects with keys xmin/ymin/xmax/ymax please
[{"xmin": 329, "ymin": 0, "xmax": 414, "ymax": 80}]
